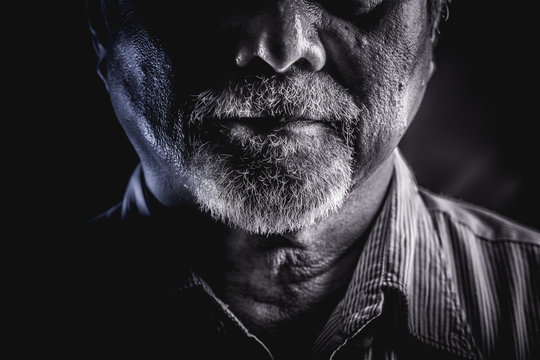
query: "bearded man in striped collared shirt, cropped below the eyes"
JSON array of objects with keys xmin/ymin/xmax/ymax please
[{"xmin": 83, "ymin": 0, "xmax": 540, "ymax": 359}]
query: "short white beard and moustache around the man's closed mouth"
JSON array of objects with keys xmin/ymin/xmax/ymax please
[{"xmin": 175, "ymin": 72, "xmax": 361, "ymax": 234}]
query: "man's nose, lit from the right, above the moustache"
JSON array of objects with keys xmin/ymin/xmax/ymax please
[{"xmin": 236, "ymin": 0, "xmax": 326, "ymax": 73}]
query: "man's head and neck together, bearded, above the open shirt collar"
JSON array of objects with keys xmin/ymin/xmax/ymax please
[{"xmin": 90, "ymin": 0, "xmax": 433, "ymax": 359}]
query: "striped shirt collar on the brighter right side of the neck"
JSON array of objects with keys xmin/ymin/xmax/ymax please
[{"xmin": 315, "ymin": 150, "xmax": 478, "ymax": 358}]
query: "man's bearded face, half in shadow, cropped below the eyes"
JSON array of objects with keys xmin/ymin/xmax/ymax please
[{"xmin": 100, "ymin": 0, "xmax": 433, "ymax": 233}]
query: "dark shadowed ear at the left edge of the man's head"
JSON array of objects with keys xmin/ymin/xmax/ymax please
[{"xmin": 86, "ymin": 0, "xmax": 109, "ymax": 91}]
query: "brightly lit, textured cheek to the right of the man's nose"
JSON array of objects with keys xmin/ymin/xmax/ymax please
[{"xmin": 322, "ymin": 1, "xmax": 431, "ymax": 168}]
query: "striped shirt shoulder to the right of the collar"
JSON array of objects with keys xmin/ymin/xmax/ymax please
[{"xmin": 420, "ymin": 190, "xmax": 540, "ymax": 358}]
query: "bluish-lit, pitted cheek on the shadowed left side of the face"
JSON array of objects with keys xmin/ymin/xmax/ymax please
[{"xmin": 107, "ymin": 31, "xmax": 190, "ymax": 176}]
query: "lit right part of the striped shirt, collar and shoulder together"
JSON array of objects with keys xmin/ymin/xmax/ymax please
[{"xmin": 314, "ymin": 153, "xmax": 540, "ymax": 359}]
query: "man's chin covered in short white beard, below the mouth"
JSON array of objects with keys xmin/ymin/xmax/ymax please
[{"xmin": 186, "ymin": 125, "xmax": 353, "ymax": 235}]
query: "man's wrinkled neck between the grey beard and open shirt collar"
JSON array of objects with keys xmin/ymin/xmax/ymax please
[{"xmin": 192, "ymin": 156, "xmax": 393, "ymax": 349}]
